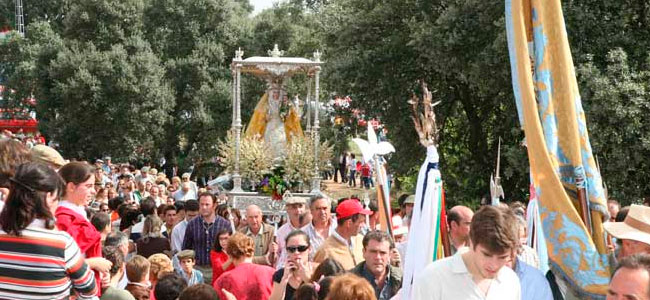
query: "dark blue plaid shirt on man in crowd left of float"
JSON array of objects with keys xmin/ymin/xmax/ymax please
[{"xmin": 183, "ymin": 216, "xmax": 232, "ymax": 267}]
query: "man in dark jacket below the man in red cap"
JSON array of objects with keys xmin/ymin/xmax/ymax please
[{"xmin": 351, "ymin": 230, "xmax": 402, "ymax": 300}]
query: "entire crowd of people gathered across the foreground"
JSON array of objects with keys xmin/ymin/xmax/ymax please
[{"xmin": 0, "ymin": 138, "xmax": 650, "ymax": 300}]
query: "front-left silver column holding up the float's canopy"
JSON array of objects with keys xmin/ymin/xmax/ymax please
[{"xmin": 232, "ymin": 49, "xmax": 244, "ymax": 192}]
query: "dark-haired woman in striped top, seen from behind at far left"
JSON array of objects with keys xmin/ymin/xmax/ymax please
[{"xmin": 0, "ymin": 163, "xmax": 98, "ymax": 299}]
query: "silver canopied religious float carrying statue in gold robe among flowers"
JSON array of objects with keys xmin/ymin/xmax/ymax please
[{"xmin": 219, "ymin": 45, "xmax": 332, "ymax": 223}]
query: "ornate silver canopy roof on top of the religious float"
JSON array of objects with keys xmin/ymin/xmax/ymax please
[{"xmin": 231, "ymin": 44, "xmax": 323, "ymax": 77}]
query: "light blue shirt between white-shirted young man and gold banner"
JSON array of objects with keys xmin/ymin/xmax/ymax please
[{"xmin": 515, "ymin": 255, "xmax": 553, "ymax": 300}]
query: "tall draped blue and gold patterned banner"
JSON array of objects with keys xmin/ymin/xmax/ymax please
[{"xmin": 506, "ymin": 0, "xmax": 610, "ymax": 298}]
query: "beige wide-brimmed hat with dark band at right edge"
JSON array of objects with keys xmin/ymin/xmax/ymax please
[{"xmin": 603, "ymin": 204, "xmax": 650, "ymax": 245}]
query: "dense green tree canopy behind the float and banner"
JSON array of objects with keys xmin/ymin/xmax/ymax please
[{"xmin": 0, "ymin": 0, "xmax": 650, "ymax": 204}]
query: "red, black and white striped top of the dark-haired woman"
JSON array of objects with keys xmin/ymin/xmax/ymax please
[{"xmin": 0, "ymin": 219, "xmax": 97, "ymax": 299}]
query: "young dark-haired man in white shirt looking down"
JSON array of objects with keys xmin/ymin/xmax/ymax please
[{"xmin": 412, "ymin": 206, "xmax": 521, "ymax": 300}]
